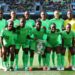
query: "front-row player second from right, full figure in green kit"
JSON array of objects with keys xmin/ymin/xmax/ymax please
[{"xmin": 46, "ymin": 23, "xmax": 61, "ymax": 70}]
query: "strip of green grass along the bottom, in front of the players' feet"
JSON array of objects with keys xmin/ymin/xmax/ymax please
[{"xmin": 0, "ymin": 71, "xmax": 75, "ymax": 75}]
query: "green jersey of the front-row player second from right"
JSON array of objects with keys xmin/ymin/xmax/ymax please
[{"xmin": 47, "ymin": 30, "xmax": 60, "ymax": 47}]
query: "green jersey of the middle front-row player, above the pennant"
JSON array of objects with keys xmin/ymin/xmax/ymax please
[{"xmin": 31, "ymin": 28, "xmax": 45, "ymax": 50}]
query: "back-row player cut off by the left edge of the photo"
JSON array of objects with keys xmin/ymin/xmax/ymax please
[{"xmin": 0, "ymin": 10, "xmax": 7, "ymax": 69}]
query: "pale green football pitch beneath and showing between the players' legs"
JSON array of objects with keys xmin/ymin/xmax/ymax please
[{"xmin": 0, "ymin": 50, "xmax": 75, "ymax": 75}]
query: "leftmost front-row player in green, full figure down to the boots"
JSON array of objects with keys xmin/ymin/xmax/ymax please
[{"xmin": 0, "ymin": 21, "xmax": 16, "ymax": 71}]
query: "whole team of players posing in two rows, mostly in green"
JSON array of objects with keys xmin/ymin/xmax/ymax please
[{"xmin": 0, "ymin": 10, "xmax": 75, "ymax": 71}]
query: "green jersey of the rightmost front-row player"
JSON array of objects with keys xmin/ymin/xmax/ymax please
[{"xmin": 61, "ymin": 30, "xmax": 75, "ymax": 47}]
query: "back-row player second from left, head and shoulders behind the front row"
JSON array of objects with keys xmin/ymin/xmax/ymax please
[{"xmin": 8, "ymin": 11, "xmax": 20, "ymax": 28}]
